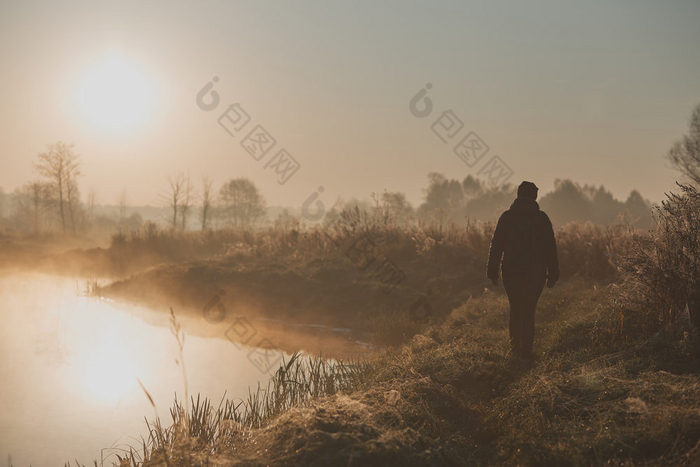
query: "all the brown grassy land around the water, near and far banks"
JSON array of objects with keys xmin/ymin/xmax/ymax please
[{"xmin": 23, "ymin": 188, "xmax": 688, "ymax": 465}]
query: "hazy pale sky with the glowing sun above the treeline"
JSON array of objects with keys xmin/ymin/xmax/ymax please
[{"xmin": 0, "ymin": 0, "xmax": 700, "ymax": 206}]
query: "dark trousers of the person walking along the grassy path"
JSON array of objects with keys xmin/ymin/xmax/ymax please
[{"xmin": 503, "ymin": 272, "xmax": 545, "ymax": 358}]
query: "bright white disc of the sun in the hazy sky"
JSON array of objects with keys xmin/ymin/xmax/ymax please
[{"xmin": 78, "ymin": 54, "xmax": 155, "ymax": 134}]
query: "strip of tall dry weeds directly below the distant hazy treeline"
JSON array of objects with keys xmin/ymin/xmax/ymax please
[{"xmin": 67, "ymin": 207, "xmax": 643, "ymax": 281}]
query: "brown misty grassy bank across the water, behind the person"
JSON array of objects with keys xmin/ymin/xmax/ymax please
[{"xmin": 83, "ymin": 221, "xmax": 639, "ymax": 345}]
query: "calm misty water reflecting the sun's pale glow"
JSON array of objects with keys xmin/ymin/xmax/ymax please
[{"xmin": 0, "ymin": 274, "xmax": 278, "ymax": 466}]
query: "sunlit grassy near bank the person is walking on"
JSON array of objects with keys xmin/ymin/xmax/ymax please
[{"xmin": 97, "ymin": 280, "xmax": 700, "ymax": 465}]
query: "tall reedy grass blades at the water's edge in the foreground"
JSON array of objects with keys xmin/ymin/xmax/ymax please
[{"xmin": 134, "ymin": 353, "xmax": 370, "ymax": 465}]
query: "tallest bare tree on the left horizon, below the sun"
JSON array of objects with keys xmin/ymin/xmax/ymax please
[{"xmin": 36, "ymin": 141, "xmax": 80, "ymax": 233}]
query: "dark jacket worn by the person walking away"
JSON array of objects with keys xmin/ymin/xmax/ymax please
[{"xmin": 487, "ymin": 198, "xmax": 559, "ymax": 282}]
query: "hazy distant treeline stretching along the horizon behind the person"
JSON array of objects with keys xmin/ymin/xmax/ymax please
[{"xmin": 0, "ymin": 169, "xmax": 653, "ymax": 238}]
